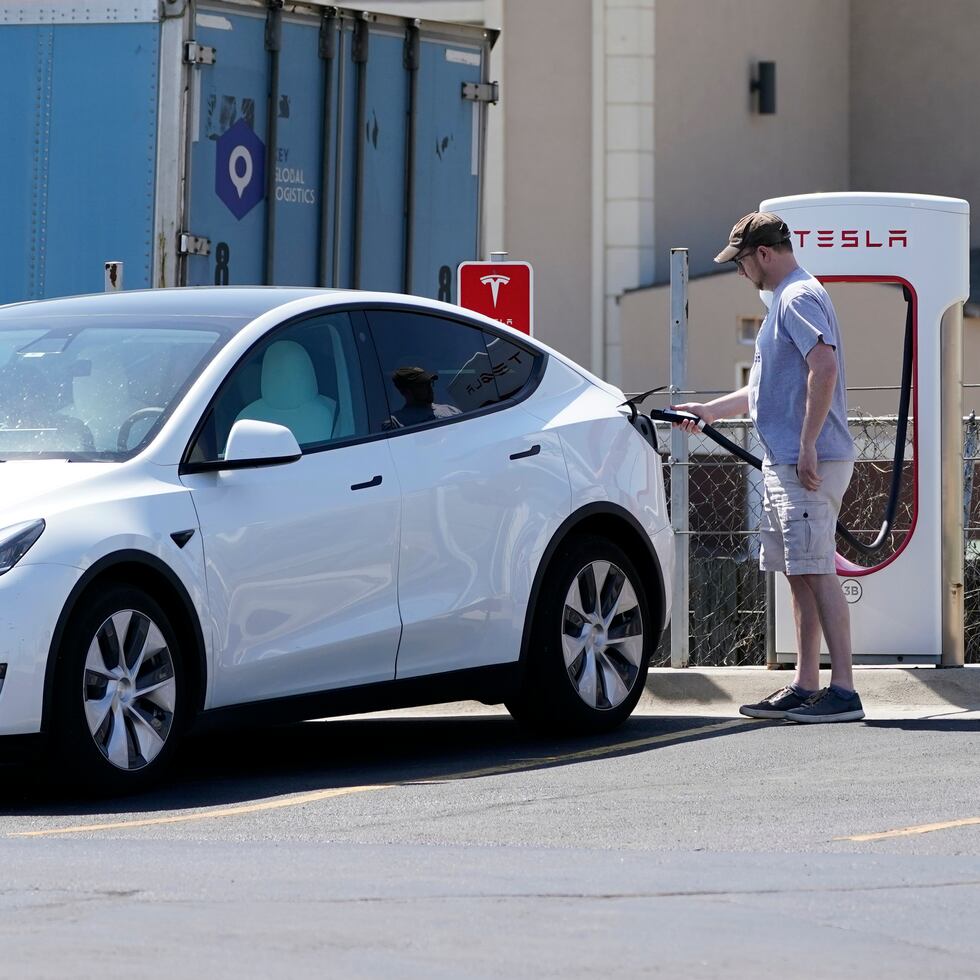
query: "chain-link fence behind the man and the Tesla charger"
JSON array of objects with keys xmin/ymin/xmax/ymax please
[{"xmin": 654, "ymin": 391, "xmax": 980, "ymax": 667}]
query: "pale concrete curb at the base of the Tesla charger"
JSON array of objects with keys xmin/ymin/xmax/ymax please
[{"xmin": 643, "ymin": 664, "xmax": 980, "ymax": 714}]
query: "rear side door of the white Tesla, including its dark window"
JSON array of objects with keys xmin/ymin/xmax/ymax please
[{"xmin": 367, "ymin": 309, "xmax": 571, "ymax": 678}]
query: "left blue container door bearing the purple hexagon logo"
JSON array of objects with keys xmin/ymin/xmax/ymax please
[{"xmin": 186, "ymin": 8, "xmax": 339, "ymax": 286}]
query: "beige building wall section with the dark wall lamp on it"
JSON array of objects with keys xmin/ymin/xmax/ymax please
[{"xmin": 656, "ymin": 0, "xmax": 852, "ymax": 284}]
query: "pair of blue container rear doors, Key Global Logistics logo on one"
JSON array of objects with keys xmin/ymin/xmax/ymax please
[{"xmin": 185, "ymin": 7, "xmax": 485, "ymax": 301}]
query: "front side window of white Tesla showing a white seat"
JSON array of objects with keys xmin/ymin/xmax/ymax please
[{"xmin": 189, "ymin": 313, "xmax": 371, "ymax": 462}]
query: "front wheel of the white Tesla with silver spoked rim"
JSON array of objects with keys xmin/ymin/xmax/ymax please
[{"xmin": 49, "ymin": 585, "xmax": 188, "ymax": 794}]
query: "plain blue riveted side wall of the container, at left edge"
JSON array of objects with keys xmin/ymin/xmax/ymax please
[{"xmin": 0, "ymin": 23, "xmax": 160, "ymax": 303}]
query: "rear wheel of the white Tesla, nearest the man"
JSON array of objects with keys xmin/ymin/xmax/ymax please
[{"xmin": 506, "ymin": 535, "xmax": 654, "ymax": 734}]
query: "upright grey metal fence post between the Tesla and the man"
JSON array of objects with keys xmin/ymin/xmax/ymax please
[{"xmin": 670, "ymin": 248, "xmax": 691, "ymax": 667}]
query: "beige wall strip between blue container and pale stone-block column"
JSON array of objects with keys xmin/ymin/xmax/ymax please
[{"xmin": 503, "ymin": 0, "xmax": 593, "ymax": 364}]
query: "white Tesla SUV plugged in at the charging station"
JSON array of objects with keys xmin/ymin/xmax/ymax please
[{"xmin": 0, "ymin": 287, "xmax": 673, "ymax": 791}]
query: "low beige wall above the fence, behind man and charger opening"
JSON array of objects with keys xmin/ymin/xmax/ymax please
[{"xmin": 620, "ymin": 272, "xmax": 980, "ymax": 415}]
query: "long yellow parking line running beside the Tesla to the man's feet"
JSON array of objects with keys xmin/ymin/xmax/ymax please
[{"xmin": 7, "ymin": 720, "xmax": 756, "ymax": 837}]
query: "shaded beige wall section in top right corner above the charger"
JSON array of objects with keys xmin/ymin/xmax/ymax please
[{"xmin": 850, "ymin": 0, "xmax": 980, "ymax": 247}]
